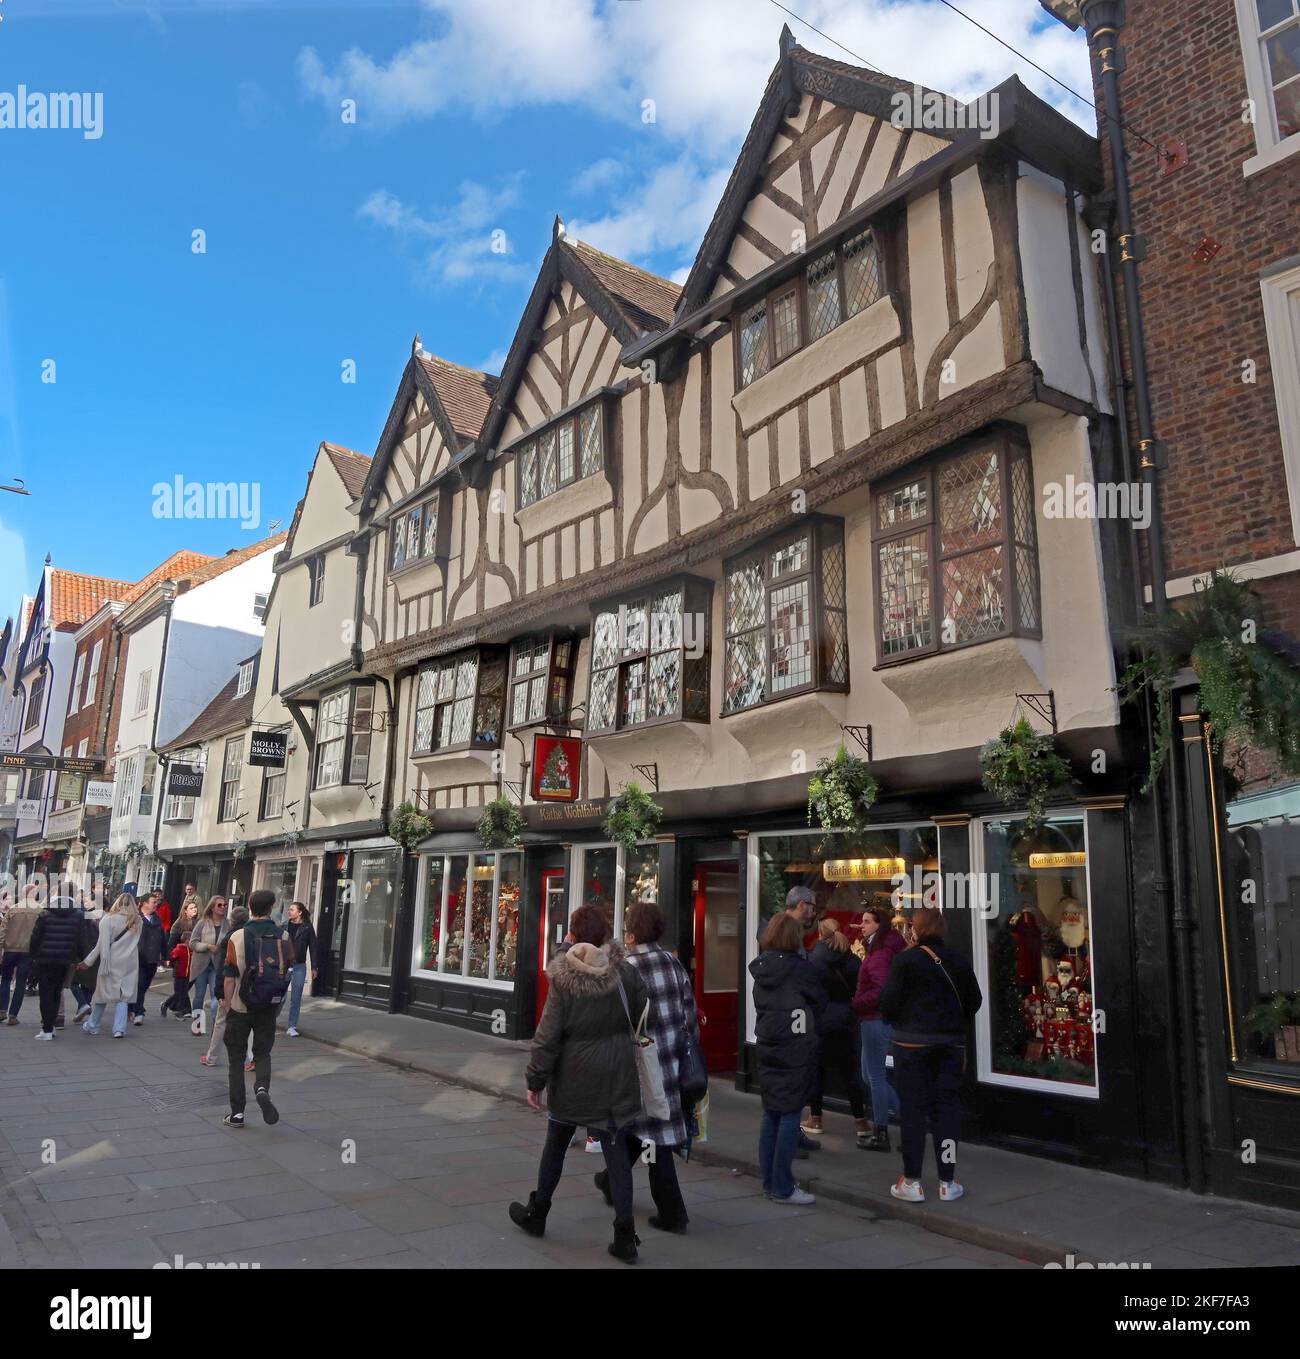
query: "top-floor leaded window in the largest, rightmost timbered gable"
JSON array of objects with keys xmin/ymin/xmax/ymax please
[{"xmin": 736, "ymin": 226, "xmax": 880, "ymax": 387}]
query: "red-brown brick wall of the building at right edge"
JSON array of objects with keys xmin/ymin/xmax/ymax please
[{"xmin": 1096, "ymin": 0, "xmax": 1300, "ymax": 636}]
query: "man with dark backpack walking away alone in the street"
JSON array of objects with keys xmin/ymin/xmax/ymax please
[{"xmin": 221, "ymin": 887, "xmax": 293, "ymax": 1128}]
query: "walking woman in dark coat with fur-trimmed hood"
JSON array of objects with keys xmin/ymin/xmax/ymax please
[{"xmin": 509, "ymin": 905, "xmax": 648, "ymax": 1264}]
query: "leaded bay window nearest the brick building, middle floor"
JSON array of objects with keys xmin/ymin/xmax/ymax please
[{"xmin": 872, "ymin": 432, "xmax": 1042, "ymax": 665}]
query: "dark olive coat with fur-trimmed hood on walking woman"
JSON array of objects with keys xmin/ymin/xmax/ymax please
[{"xmin": 527, "ymin": 940, "xmax": 648, "ymax": 1128}]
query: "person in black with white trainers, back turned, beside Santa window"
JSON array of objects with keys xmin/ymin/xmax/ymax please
[{"xmin": 880, "ymin": 906, "xmax": 983, "ymax": 1203}]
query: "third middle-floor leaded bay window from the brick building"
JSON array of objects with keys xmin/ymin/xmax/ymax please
[{"xmin": 587, "ymin": 576, "xmax": 713, "ymax": 735}]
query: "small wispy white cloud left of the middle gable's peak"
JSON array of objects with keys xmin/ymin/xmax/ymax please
[{"xmin": 359, "ymin": 174, "xmax": 523, "ymax": 283}]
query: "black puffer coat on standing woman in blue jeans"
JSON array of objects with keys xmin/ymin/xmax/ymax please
[{"xmin": 750, "ymin": 949, "xmax": 826, "ymax": 1113}]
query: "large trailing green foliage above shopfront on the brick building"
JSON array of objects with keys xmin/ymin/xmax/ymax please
[{"xmin": 1115, "ymin": 571, "xmax": 1300, "ymax": 792}]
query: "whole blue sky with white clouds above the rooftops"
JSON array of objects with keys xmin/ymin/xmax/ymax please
[{"xmin": 0, "ymin": 0, "xmax": 1092, "ymax": 606}]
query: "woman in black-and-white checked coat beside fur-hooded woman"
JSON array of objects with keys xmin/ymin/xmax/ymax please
[{"xmin": 595, "ymin": 901, "xmax": 700, "ymax": 1235}]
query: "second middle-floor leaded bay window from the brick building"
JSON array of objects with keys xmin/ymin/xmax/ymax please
[{"xmin": 723, "ymin": 519, "xmax": 849, "ymax": 715}]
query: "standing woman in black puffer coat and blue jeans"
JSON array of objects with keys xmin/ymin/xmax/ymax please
[{"xmin": 750, "ymin": 912, "xmax": 826, "ymax": 1204}]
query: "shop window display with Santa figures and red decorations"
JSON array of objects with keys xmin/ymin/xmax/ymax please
[{"xmin": 983, "ymin": 815, "xmax": 1096, "ymax": 1089}]
